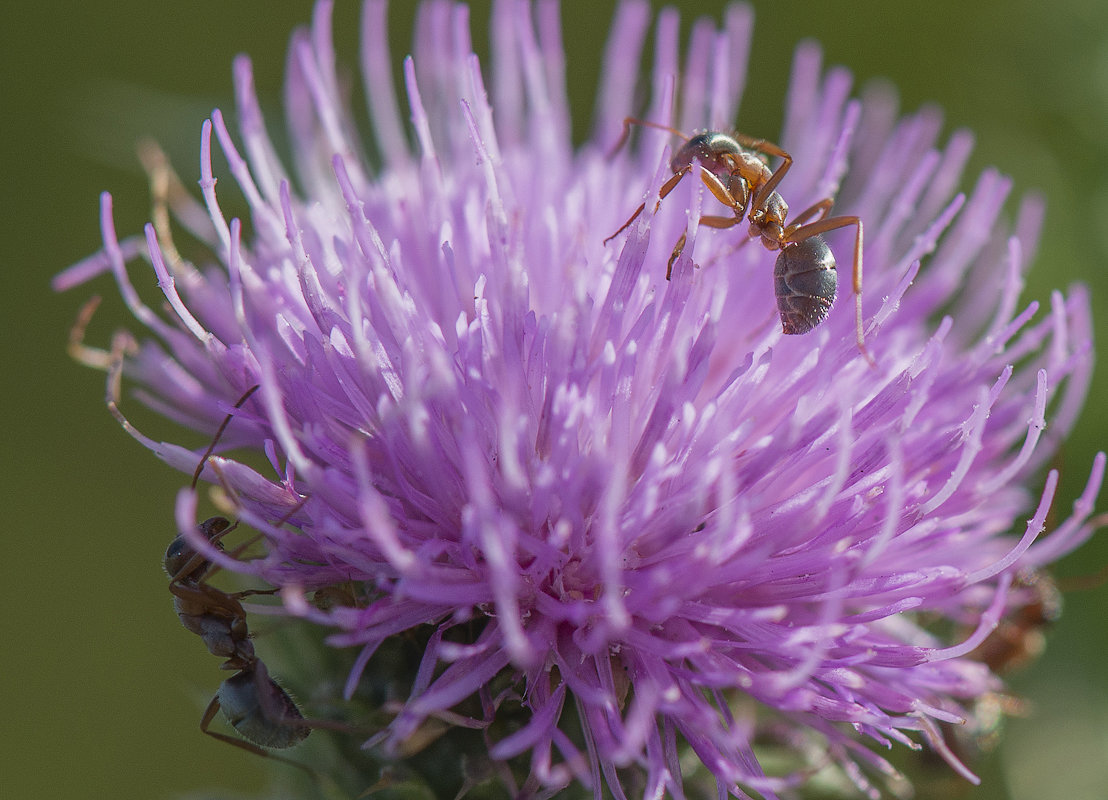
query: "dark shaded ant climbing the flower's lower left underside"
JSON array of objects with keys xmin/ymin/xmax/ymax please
[{"xmin": 164, "ymin": 386, "xmax": 315, "ymax": 772}]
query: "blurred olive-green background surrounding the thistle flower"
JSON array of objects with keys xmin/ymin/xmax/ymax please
[{"xmin": 0, "ymin": 0, "xmax": 1108, "ymax": 800}]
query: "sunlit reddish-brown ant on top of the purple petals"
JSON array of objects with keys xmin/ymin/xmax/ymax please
[{"xmin": 604, "ymin": 116, "xmax": 874, "ymax": 366}]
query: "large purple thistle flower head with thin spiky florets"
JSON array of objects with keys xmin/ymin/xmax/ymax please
[{"xmin": 55, "ymin": 0, "xmax": 1105, "ymax": 798}]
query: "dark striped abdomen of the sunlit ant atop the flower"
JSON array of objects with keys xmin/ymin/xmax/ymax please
[{"xmin": 773, "ymin": 236, "xmax": 839, "ymax": 334}]
